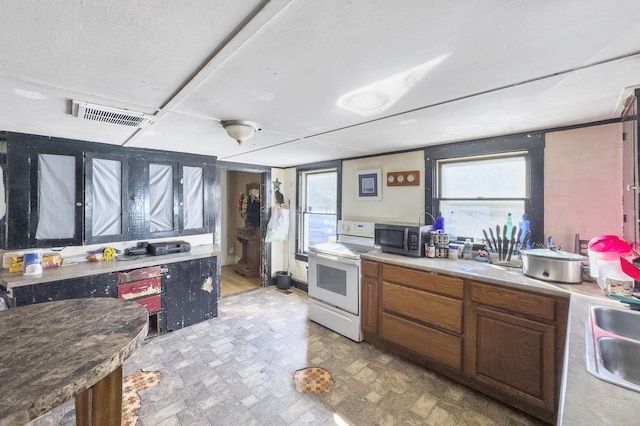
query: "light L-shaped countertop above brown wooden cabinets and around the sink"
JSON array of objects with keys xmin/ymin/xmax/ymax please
[{"xmin": 361, "ymin": 251, "xmax": 640, "ymax": 426}]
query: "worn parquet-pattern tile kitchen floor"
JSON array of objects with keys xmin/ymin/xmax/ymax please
[{"xmin": 30, "ymin": 286, "xmax": 540, "ymax": 426}]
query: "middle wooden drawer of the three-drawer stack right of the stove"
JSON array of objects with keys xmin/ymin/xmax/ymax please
[{"xmin": 382, "ymin": 282, "xmax": 462, "ymax": 334}]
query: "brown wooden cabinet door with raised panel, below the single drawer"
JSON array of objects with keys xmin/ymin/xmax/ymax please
[{"xmin": 466, "ymin": 306, "xmax": 557, "ymax": 413}]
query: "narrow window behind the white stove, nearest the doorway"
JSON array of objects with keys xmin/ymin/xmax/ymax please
[{"xmin": 296, "ymin": 162, "xmax": 340, "ymax": 255}]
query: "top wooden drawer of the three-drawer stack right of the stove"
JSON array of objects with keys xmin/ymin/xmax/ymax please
[{"xmin": 382, "ymin": 265, "xmax": 464, "ymax": 299}]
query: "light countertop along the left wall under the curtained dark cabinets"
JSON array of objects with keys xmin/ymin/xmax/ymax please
[{"xmin": 0, "ymin": 244, "xmax": 220, "ymax": 291}]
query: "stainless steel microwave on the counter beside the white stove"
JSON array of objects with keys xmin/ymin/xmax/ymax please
[{"xmin": 374, "ymin": 222, "xmax": 433, "ymax": 257}]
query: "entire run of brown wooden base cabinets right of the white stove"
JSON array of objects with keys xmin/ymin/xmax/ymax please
[{"xmin": 361, "ymin": 259, "xmax": 569, "ymax": 423}]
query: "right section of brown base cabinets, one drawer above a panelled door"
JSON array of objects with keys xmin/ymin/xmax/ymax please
[{"xmin": 465, "ymin": 281, "xmax": 568, "ymax": 422}]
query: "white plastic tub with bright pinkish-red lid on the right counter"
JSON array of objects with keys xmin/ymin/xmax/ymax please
[{"xmin": 588, "ymin": 235, "xmax": 631, "ymax": 290}]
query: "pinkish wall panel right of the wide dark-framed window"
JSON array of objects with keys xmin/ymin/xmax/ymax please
[{"xmin": 544, "ymin": 123, "xmax": 623, "ymax": 251}]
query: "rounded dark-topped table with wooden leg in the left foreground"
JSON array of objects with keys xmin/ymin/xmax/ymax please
[{"xmin": 0, "ymin": 298, "xmax": 148, "ymax": 426}]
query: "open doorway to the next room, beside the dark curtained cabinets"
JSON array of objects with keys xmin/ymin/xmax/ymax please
[{"xmin": 220, "ymin": 167, "xmax": 271, "ymax": 297}]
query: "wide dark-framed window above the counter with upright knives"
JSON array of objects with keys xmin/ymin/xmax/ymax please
[{"xmin": 425, "ymin": 133, "xmax": 544, "ymax": 245}]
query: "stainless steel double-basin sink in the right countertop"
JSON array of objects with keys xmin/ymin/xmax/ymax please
[{"xmin": 585, "ymin": 304, "xmax": 640, "ymax": 392}]
